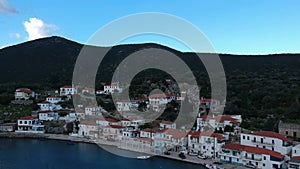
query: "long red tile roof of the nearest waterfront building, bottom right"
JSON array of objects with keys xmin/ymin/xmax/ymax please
[{"xmin": 222, "ymin": 144, "xmax": 284, "ymax": 159}]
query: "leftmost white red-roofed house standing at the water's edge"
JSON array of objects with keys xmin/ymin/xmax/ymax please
[{"xmin": 15, "ymin": 116, "xmax": 44, "ymax": 133}]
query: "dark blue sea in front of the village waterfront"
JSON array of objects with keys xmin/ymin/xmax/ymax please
[{"xmin": 0, "ymin": 138, "xmax": 205, "ymax": 169}]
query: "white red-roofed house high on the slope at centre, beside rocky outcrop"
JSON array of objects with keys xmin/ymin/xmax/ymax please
[{"xmin": 148, "ymin": 94, "xmax": 176, "ymax": 112}]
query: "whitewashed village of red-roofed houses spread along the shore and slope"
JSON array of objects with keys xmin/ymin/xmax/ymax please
[{"xmin": 0, "ymin": 83, "xmax": 300, "ymax": 169}]
